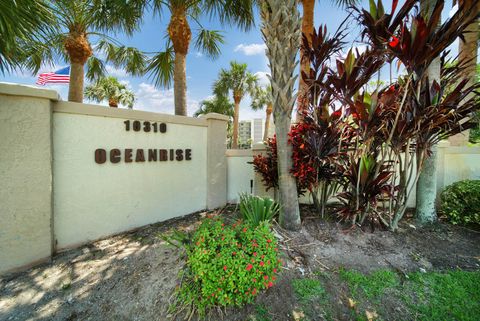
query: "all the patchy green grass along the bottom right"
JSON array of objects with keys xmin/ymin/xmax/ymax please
[{"xmin": 292, "ymin": 269, "xmax": 480, "ymax": 321}]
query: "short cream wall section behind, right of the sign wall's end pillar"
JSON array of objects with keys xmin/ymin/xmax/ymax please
[{"xmin": 226, "ymin": 149, "xmax": 255, "ymax": 203}]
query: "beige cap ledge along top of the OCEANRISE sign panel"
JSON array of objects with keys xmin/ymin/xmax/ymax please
[{"xmin": 53, "ymin": 101, "xmax": 208, "ymax": 127}]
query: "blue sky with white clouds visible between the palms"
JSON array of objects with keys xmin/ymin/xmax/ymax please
[{"xmin": 0, "ymin": 0, "xmax": 464, "ymax": 120}]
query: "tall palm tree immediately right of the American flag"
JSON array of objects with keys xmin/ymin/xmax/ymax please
[{"xmin": 25, "ymin": 0, "xmax": 145, "ymax": 102}]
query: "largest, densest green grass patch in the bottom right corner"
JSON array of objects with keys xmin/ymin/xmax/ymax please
[{"xmin": 403, "ymin": 271, "xmax": 480, "ymax": 321}]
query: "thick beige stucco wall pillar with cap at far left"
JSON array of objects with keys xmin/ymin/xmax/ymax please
[{"xmin": 0, "ymin": 84, "xmax": 58, "ymax": 273}]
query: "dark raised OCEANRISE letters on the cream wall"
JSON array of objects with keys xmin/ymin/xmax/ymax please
[{"xmin": 95, "ymin": 148, "xmax": 192, "ymax": 164}]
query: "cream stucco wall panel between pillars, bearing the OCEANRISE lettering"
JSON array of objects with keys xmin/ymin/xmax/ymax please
[{"xmin": 53, "ymin": 102, "xmax": 210, "ymax": 249}]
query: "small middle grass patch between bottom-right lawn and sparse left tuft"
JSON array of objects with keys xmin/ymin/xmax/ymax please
[{"xmin": 339, "ymin": 269, "xmax": 400, "ymax": 300}]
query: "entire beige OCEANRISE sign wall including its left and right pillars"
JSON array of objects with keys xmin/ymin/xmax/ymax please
[{"xmin": 0, "ymin": 83, "xmax": 227, "ymax": 274}]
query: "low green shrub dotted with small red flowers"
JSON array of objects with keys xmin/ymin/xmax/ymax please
[{"xmin": 177, "ymin": 219, "xmax": 281, "ymax": 315}]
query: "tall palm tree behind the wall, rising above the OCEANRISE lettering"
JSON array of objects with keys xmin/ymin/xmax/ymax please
[{"xmin": 144, "ymin": 0, "xmax": 254, "ymax": 116}]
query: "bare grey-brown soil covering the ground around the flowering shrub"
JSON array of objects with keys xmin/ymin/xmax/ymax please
[{"xmin": 0, "ymin": 206, "xmax": 480, "ymax": 321}]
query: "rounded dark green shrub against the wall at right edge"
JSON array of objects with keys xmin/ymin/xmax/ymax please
[{"xmin": 441, "ymin": 180, "xmax": 480, "ymax": 224}]
